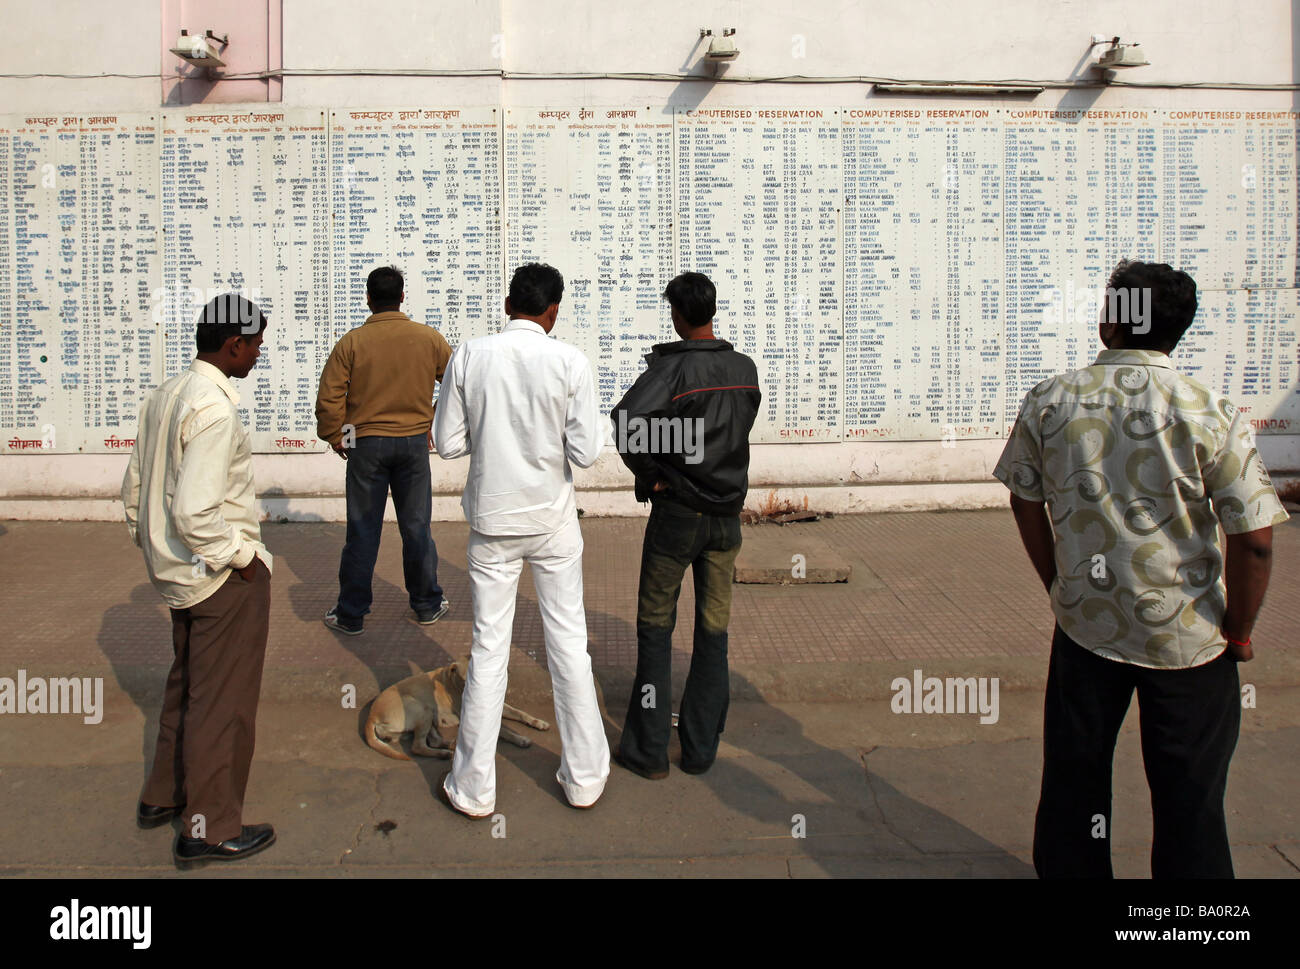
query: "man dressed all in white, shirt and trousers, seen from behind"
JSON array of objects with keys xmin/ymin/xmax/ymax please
[{"xmin": 433, "ymin": 263, "xmax": 610, "ymax": 818}]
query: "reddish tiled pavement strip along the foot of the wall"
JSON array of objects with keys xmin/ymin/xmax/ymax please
[{"xmin": 0, "ymin": 510, "xmax": 1300, "ymax": 676}]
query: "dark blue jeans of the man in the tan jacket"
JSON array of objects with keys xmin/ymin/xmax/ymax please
[{"xmin": 338, "ymin": 434, "xmax": 442, "ymax": 626}]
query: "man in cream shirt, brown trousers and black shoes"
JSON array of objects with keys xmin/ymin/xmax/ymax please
[{"xmin": 122, "ymin": 294, "xmax": 276, "ymax": 866}]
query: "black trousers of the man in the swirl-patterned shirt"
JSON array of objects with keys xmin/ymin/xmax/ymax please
[{"xmin": 1034, "ymin": 627, "xmax": 1242, "ymax": 878}]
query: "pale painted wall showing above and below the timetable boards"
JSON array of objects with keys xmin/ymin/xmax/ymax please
[{"xmin": 0, "ymin": 0, "xmax": 1300, "ymax": 519}]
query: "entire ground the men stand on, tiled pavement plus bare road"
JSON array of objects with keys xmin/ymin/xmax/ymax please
[{"xmin": 0, "ymin": 511, "xmax": 1300, "ymax": 878}]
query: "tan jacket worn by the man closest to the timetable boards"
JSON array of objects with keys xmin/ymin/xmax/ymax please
[{"xmin": 316, "ymin": 310, "xmax": 451, "ymax": 445}]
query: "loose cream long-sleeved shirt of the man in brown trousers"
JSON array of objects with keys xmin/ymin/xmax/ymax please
[{"xmin": 122, "ymin": 360, "xmax": 270, "ymax": 609}]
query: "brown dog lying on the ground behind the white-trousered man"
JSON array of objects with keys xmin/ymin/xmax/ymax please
[{"xmin": 365, "ymin": 656, "xmax": 551, "ymax": 761}]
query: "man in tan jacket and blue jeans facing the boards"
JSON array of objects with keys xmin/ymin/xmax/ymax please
[{"xmin": 316, "ymin": 265, "xmax": 451, "ymax": 636}]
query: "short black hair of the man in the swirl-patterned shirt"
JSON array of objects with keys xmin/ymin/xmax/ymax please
[{"xmin": 1106, "ymin": 259, "xmax": 1196, "ymax": 354}]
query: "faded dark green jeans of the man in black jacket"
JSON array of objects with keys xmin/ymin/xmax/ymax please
[{"xmin": 619, "ymin": 497, "xmax": 741, "ymax": 773}]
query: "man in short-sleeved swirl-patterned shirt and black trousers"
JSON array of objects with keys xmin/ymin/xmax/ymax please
[{"xmin": 993, "ymin": 263, "xmax": 1287, "ymax": 878}]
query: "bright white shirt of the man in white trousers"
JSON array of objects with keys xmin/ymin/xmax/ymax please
[{"xmin": 433, "ymin": 320, "xmax": 605, "ymax": 535}]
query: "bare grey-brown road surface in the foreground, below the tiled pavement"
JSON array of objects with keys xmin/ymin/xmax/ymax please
[{"xmin": 0, "ymin": 691, "xmax": 1300, "ymax": 878}]
